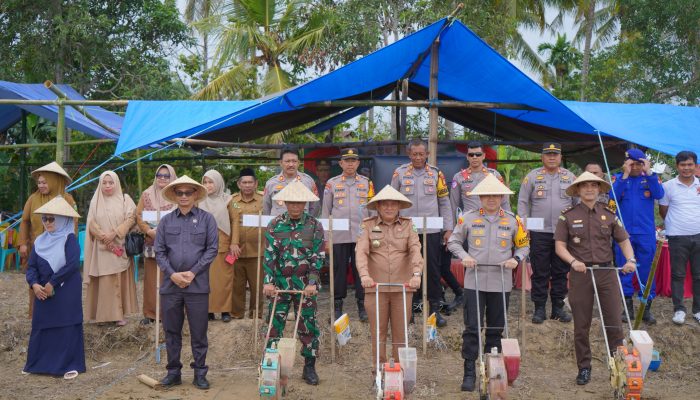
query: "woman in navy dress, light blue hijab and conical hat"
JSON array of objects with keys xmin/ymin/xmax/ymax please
[{"xmin": 23, "ymin": 196, "xmax": 85, "ymax": 379}]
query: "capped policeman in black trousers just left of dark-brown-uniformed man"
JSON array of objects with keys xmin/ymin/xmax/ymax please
[{"xmin": 518, "ymin": 143, "xmax": 576, "ymax": 324}]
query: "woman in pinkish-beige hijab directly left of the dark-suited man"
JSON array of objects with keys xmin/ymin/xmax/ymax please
[{"xmin": 136, "ymin": 164, "xmax": 177, "ymax": 325}]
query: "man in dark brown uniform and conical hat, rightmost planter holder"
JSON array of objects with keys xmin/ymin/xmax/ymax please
[{"xmin": 554, "ymin": 172, "xmax": 636, "ymax": 385}]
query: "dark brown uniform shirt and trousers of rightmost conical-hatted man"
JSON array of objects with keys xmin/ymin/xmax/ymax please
[{"xmin": 554, "ymin": 203, "xmax": 629, "ymax": 368}]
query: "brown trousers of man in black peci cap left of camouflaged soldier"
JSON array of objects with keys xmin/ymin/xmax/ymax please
[{"xmin": 231, "ymin": 257, "xmax": 264, "ymax": 318}]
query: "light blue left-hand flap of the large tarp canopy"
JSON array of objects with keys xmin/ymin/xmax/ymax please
[{"xmin": 114, "ymin": 100, "xmax": 259, "ymax": 154}]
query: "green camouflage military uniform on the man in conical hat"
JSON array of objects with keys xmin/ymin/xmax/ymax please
[{"xmin": 264, "ymin": 212, "xmax": 325, "ymax": 357}]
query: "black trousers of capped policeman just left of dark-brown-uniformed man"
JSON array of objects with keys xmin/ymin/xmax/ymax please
[{"xmin": 530, "ymin": 231, "xmax": 570, "ymax": 306}]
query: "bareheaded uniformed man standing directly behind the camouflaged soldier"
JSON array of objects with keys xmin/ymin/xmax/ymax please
[{"xmin": 263, "ymin": 147, "xmax": 319, "ymax": 216}]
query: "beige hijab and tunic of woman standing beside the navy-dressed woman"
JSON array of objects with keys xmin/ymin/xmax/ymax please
[{"xmin": 85, "ymin": 171, "xmax": 136, "ymax": 277}]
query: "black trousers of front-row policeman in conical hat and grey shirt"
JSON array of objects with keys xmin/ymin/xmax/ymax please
[{"xmin": 462, "ymin": 289, "xmax": 510, "ymax": 360}]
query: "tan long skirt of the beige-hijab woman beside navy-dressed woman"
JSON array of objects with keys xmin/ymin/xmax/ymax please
[{"xmin": 85, "ymin": 263, "xmax": 139, "ymax": 322}]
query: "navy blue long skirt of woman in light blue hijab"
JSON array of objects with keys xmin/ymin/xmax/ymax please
[{"xmin": 24, "ymin": 324, "xmax": 85, "ymax": 376}]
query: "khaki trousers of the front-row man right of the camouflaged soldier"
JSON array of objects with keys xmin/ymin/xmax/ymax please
[{"xmin": 365, "ymin": 290, "xmax": 413, "ymax": 368}]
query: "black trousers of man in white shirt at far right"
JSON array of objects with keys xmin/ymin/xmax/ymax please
[{"xmin": 668, "ymin": 234, "xmax": 700, "ymax": 314}]
